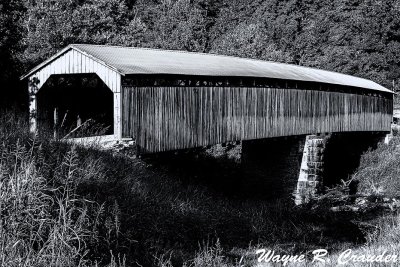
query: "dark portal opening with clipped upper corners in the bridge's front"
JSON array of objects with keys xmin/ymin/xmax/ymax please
[{"xmin": 36, "ymin": 74, "xmax": 114, "ymax": 138}]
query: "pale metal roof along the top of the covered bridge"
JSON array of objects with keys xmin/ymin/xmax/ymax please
[{"xmin": 22, "ymin": 44, "xmax": 392, "ymax": 93}]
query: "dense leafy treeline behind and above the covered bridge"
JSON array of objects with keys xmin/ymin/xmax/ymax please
[{"xmin": 0, "ymin": 0, "xmax": 400, "ymax": 109}]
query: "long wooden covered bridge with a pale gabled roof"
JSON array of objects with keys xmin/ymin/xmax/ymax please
[{"xmin": 22, "ymin": 44, "xmax": 393, "ymax": 153}]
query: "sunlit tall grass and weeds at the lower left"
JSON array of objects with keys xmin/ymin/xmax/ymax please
[{"xmin": 0, "ymin": 114, "xmax": 125, "ymax": 267}]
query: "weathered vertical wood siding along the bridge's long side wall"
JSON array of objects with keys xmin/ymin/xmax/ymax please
[{"xmin": 122, "ymin": 87, "xmax": 393, "ymax": 153}]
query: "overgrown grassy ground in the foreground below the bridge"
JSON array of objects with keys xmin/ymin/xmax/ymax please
[{"xmin": 0, "ymin": 112, "xmax": 400, "ymax": 267}]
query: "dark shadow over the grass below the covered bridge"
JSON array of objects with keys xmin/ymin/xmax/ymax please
[{"xmin": 72, "ymin": 150, "xmax": 378, "ymax": 266}]
